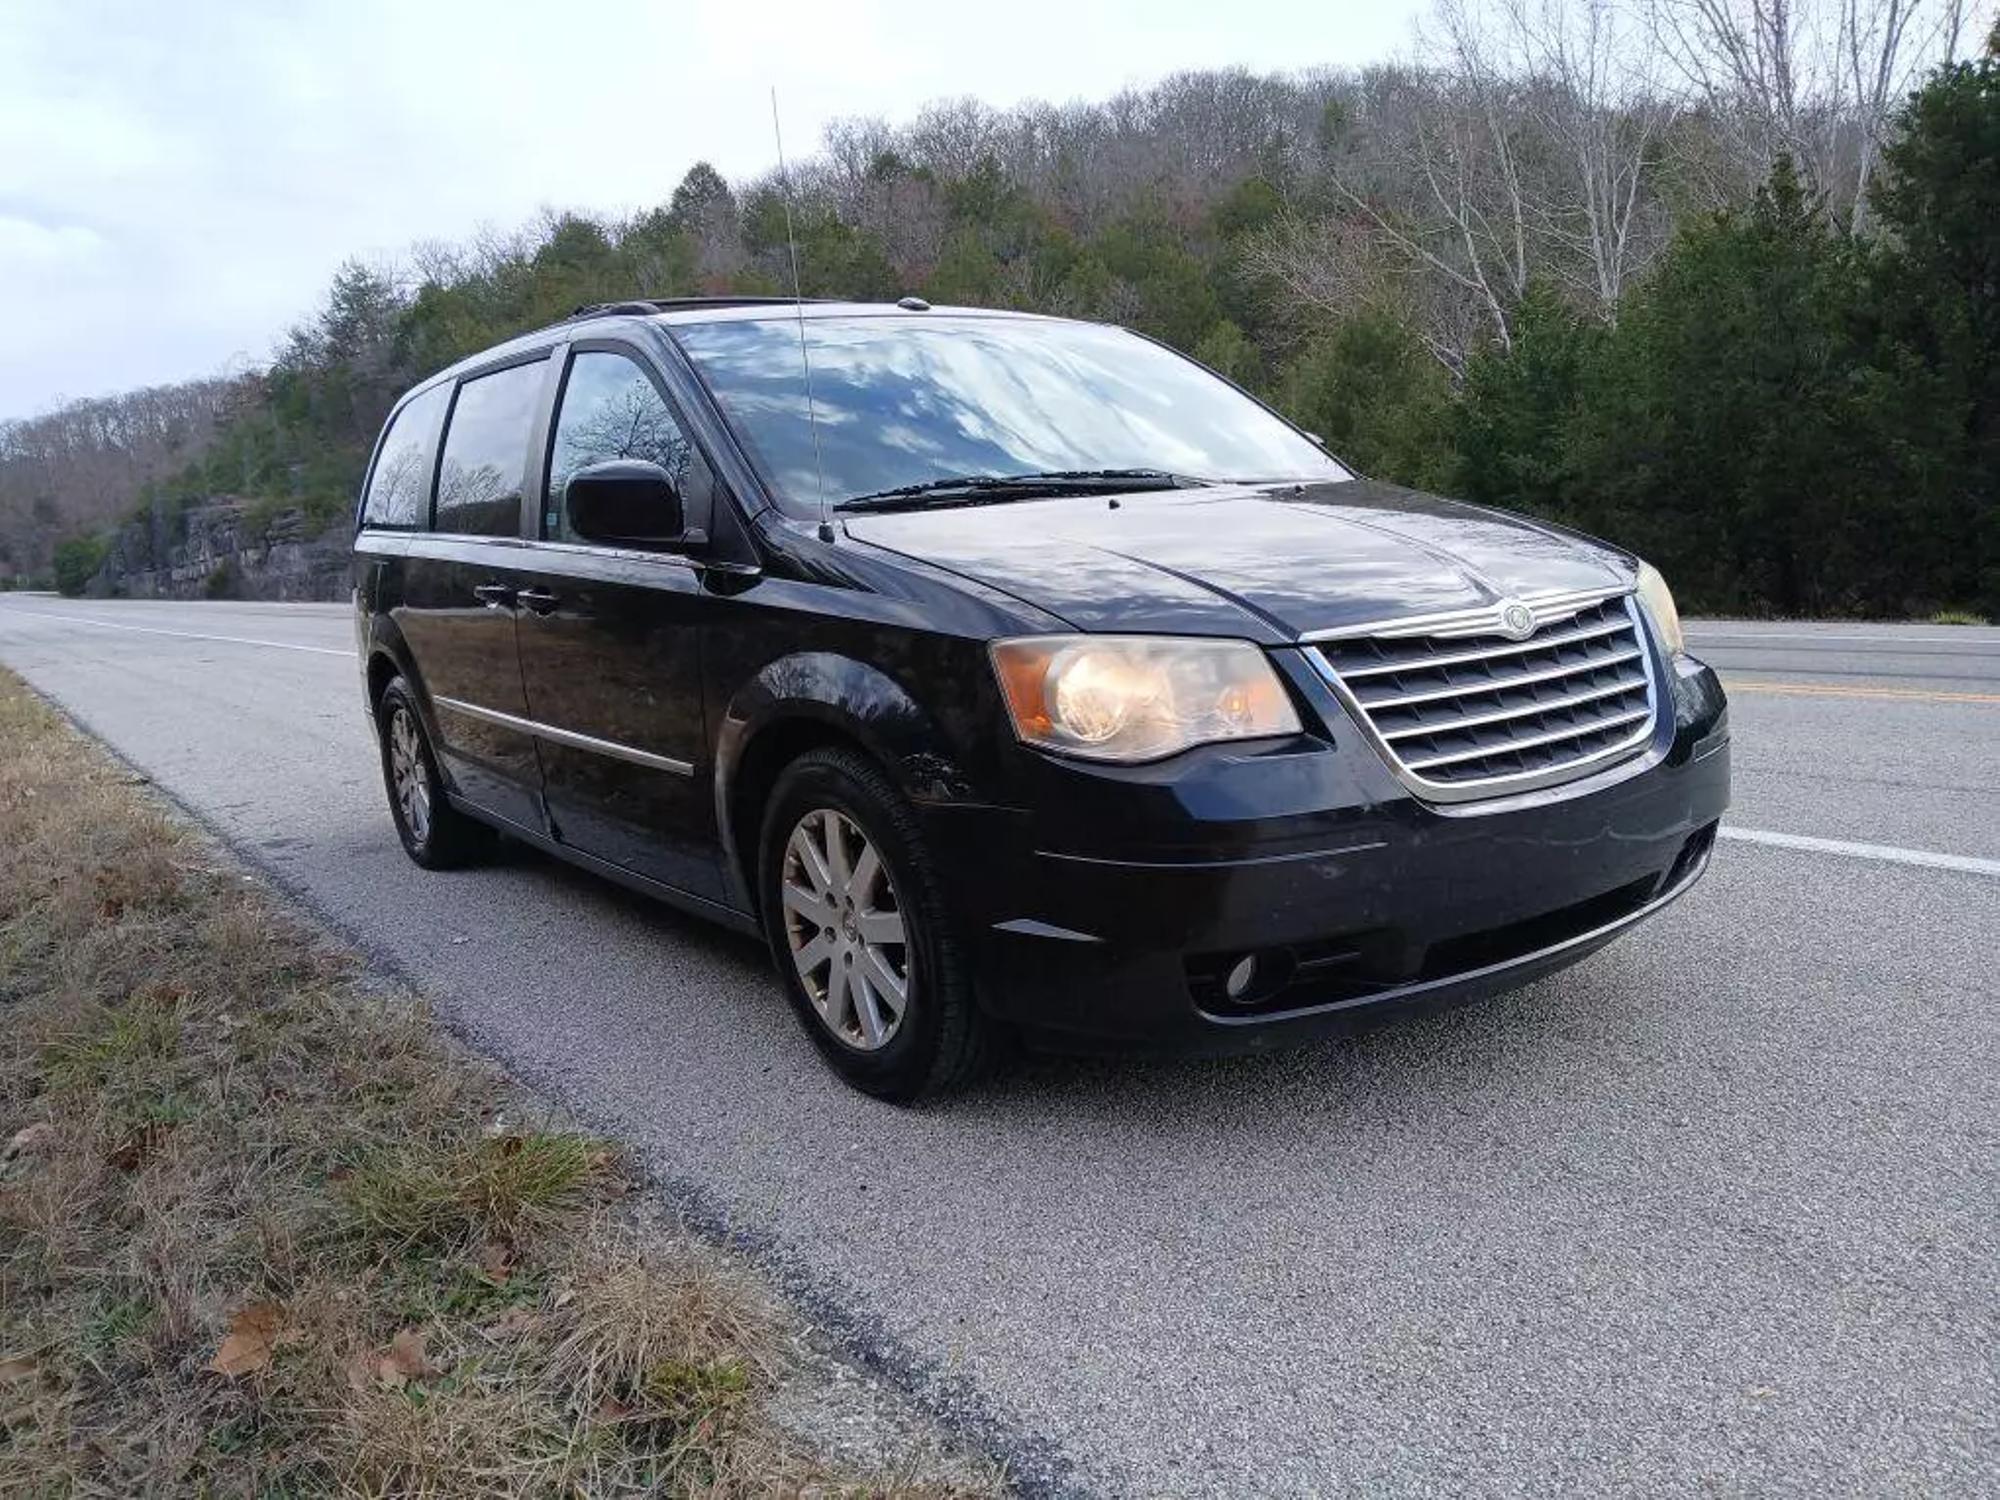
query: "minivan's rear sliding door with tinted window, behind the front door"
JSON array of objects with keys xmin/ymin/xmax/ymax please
[{"xmin": 394, "ymin": 358, "xmax": 548, "ymax": 832}]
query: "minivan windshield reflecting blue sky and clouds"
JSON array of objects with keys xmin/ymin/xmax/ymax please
[{"xmin": 672, "ymin": 314, "xmax": 1348, "ymax": 516}]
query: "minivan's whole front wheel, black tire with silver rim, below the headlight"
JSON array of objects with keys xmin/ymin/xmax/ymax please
[{"xmin": 758, "ymin": 748, "xmax": 996, "ymax": 1104}]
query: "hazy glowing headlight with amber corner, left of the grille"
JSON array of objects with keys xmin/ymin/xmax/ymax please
[{"xmin": 992, "ymin": 636, "xmax": 1298, "ymax": 760}]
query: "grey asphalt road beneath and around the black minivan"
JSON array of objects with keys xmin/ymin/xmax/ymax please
[{"xmin": 0, "ymin": 596, "xmax": 2000, "ymax": 1496}]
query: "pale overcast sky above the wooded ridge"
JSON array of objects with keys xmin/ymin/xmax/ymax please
[{"xmin": 0, "ymin": 0, "xmax": 1418, "ymax": 418}]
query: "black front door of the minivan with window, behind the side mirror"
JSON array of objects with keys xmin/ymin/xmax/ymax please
[{"xmin": 518, "ymin": 346, "xmax": 722, "ymax": 898}]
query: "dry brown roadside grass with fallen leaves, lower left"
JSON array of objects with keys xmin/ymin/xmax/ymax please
[{"xmin": 0, "ymin": 674, "xmax": 1000, "ymax": 1496}]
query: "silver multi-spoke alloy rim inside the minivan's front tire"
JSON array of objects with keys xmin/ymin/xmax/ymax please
[{"xmin": 778, "ymin": 808, "xmax": 910, "ymax": 1052}]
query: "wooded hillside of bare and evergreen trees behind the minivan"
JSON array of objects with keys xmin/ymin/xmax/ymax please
[{"xmin": 0, "ymin": 0, "xmax": 2000, "ymax": 616}]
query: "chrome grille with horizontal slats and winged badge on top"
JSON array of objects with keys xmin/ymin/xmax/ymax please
[{"xmin": 1316, "ymin": 596, "xmax": 1658, "ymax": 800}]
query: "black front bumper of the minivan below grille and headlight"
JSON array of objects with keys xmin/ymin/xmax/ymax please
[{"xmin": 926, "ymin": 658, "xmax": 1728, "ymax": 1052}]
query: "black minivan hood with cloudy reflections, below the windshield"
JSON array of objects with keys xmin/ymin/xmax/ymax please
[{"xmin": 846, "ymin": 480, "xmax": 1632, "ymax": 642}]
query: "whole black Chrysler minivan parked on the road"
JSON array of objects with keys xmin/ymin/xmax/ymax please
[{"xmin": 354, "ymin": 298, "xmax": 1728, "ymax": 1100}]
